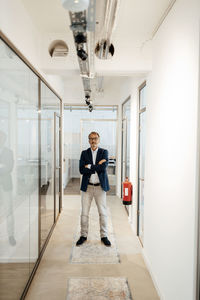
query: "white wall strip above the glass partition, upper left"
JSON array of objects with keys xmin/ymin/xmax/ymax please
[{"xmin": 0, "ymin": 0, "xmax": 64, "ymax": 96}]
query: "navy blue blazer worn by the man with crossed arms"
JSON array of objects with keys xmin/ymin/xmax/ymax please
[{"xmin": 79, "ymin": 148, "xmax": 110, "ymax": 192}]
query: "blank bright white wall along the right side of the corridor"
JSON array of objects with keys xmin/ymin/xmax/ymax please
[{"xmin": 144, "ymin": 0, "xmax": 200, "ymax": 300}]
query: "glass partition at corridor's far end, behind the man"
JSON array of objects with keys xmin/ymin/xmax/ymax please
[{"xmin": 63, "ymin": 105, "xmax": 117, "ymax": 195}]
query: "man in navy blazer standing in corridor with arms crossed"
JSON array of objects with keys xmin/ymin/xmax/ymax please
[{"xmin": 76, "ymin": 131, "xmax": 111, "ymax": 247}]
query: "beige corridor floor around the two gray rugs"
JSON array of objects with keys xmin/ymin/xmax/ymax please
[{"xmin": 26, "ymin": 195, "xmax": 159, "ymax": 300}]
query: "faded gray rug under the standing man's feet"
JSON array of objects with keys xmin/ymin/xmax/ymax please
[{"xmin": 70, "ymin": 203, "xmax": 120, "ymax": 264}]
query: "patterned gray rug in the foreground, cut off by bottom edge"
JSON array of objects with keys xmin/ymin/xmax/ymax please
[{"xmin": 66, "ymin": 277, "xmax": 132, "ymax": 300}]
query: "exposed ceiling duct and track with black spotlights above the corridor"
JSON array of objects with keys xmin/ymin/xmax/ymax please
[{"xmin": 61, "ymin": 0, "xmax": 120, "ymax": 111}]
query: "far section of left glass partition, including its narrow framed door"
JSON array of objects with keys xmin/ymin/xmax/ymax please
[{"xmin": 40, "ymin": 82, "xmax": 60, "ymax": 248}]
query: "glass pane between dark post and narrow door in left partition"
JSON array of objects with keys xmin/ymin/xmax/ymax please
[{"xmin": 40, "ymin": 82, "xmax": 60, "ymax": 248}]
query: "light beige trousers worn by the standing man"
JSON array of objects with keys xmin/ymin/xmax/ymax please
[{"xmin": 81, "ymin": 185, "xmax": 107, "ymax": 238}]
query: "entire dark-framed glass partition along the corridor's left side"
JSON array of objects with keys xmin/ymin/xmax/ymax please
[{"xmin": 0, "ymin": 39, "xmax": 61, "ymax": 300}]
